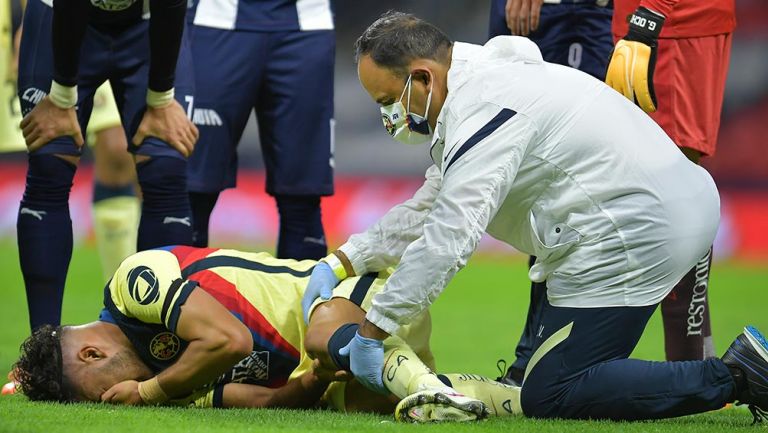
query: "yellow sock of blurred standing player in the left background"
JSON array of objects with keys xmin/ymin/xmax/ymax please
[{"xmin": 93, "ymin": 196, "xmax": 141, "ymax": 281}]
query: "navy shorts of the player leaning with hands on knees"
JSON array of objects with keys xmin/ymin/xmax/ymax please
[{"xmin": 18, "ymin": 0, "xmax": 194, "ymax": 158}]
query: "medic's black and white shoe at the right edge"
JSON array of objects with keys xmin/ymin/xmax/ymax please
[{"xmin": 722, "ymin": 326, "xmax": 768, "ymax": 424}]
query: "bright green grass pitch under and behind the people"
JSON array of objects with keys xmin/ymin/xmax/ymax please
[{"xmin": 0, "ymin": 241, "xmax": 768, "ymax": 433}]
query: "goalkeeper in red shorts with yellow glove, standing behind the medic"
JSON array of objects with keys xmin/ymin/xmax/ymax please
[{"xmin": 605, "ymin": 0, "xmax": 736, "ymax": 360}]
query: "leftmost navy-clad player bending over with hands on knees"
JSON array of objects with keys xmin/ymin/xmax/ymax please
[{"xmin": 17, "ymin": 0, "xmax": 197, "ymax": 329}]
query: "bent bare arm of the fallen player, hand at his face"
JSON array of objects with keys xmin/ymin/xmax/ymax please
[{"xmin": 101, "ymin": 289, "xmax": 253, "ymax": 404}]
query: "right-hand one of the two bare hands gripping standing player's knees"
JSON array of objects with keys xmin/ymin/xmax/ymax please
[{"xmin": 132, "ymin": 100, "xmax": 199, "ymax": 157}]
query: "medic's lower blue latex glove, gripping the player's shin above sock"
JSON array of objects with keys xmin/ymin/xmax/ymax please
[{"xmin": 339, "ymin": 333, "xmax": 389, "ymax": 394}]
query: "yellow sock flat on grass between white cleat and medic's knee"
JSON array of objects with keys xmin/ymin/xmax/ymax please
[{"xmin": 440, "ymin": 374, "xmax": 523, "ymax": 416}]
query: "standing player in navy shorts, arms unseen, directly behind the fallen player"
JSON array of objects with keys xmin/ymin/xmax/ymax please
[{"xmin": 188, "ymin": 0, "xmax": 336, "ymax": 259}]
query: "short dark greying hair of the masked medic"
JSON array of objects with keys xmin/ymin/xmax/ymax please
[{"xmin": 355, "ymin": 11, "xmax": 453, "ymax": 76}]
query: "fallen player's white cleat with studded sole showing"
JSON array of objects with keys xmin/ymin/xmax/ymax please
[{"xmin": 395, "ymin": 388, "xmax": 489, "ymax": 422}]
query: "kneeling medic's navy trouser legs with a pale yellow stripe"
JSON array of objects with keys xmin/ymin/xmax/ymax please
[{"xmin": 521, "ymin": 296, "xmax": 735, "ymax": 420}]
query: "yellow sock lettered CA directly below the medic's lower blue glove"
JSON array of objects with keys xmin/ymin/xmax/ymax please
[{"xmin": 383, "ymin": 337, "xmax": 448, "ymax": 398}]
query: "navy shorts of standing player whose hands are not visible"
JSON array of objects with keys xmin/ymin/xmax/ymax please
[{"xmin": 188, "ymin": 26, "xmax": 336, "ymax": 195}]
